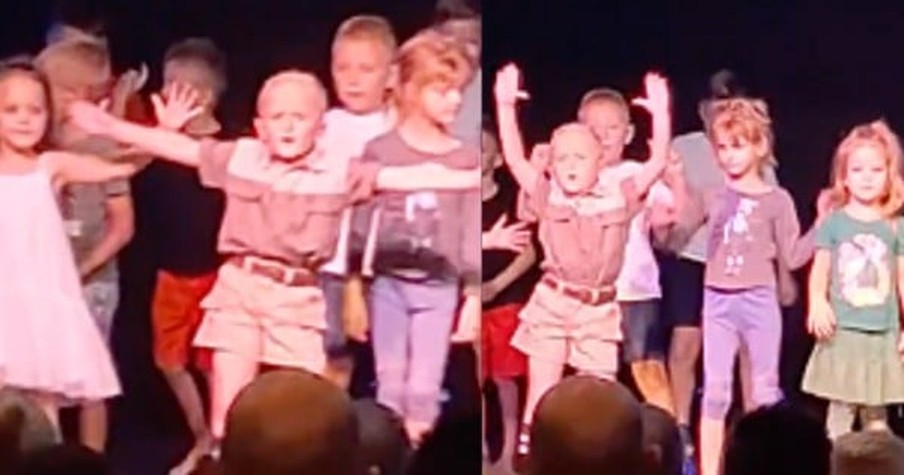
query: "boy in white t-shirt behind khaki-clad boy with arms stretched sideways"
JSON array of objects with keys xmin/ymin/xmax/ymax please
[{"xmin": 320, "ymin": 15, "xmax": 397, "ymax": 388}]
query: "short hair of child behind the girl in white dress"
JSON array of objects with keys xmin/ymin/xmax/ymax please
[{"xmin": 34, "ymin": 35, "xmax": 113, "ymax": 91}]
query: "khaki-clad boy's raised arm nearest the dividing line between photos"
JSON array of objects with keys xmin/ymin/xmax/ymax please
[{"xmin": 495, "ymin": 64, "xmax": 541, "ymax": 191}]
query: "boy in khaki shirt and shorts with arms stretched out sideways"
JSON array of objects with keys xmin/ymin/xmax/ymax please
[{"xmin": 70, "ymin": 70, "xmax": 480, "ymax": 450}]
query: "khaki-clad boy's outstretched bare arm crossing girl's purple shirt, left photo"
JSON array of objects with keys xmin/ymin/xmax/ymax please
[{"xmin": 376, "ymin": 163, "xmax": 480, "ymax": 191}]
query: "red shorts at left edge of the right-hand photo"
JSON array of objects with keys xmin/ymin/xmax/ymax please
[{"xmin": 480, "ymin": 303, "xmax": 527, "ymax": 379}]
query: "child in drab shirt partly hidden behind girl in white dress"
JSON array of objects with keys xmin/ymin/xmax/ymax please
[{"xmin": 36, "ymin": 35, "xmax": 134, "ymax": 452}]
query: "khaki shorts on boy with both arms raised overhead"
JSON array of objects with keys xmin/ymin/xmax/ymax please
[{"xmin": 512, "ymin": 283, "xmax": 622, "ymax": 378}]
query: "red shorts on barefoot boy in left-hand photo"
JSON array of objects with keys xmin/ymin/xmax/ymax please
[{"xmin": 151, "ymin": 271, "xmax": 217, "ymax": 369}]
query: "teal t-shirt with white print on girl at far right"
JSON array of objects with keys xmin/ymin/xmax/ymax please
[{"xmin": 816, "ymin": 210, "xmax": 904, "ymax": 331}]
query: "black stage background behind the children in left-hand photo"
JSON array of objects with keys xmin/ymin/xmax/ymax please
[{"xmin": 0, "ymin": 0, "xmax": 479, "ymax": 475}]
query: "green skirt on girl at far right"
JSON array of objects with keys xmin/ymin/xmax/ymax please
[{"xmin": 802, "ymin": 328, "xmax": 904, "ymax": 406}]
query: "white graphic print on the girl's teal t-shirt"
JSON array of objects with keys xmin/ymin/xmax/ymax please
[{"xmin": 836, "ymin": 234, "xmax": 891, "ymax": 307}]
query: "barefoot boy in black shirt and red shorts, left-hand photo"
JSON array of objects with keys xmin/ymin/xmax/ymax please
[{"xmin": 143, "ymin": 38, "xmax": 226, "ymax": 474}]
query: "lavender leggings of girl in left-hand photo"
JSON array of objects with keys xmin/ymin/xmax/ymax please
[{"xmin": 369, "ymin": 276, "xmax": 459, "ymax": 423}]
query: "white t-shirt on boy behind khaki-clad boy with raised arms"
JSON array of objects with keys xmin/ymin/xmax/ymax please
[{"xmin": 615, "ymin": 160, "xmax": 674, "ymax": 302}]
